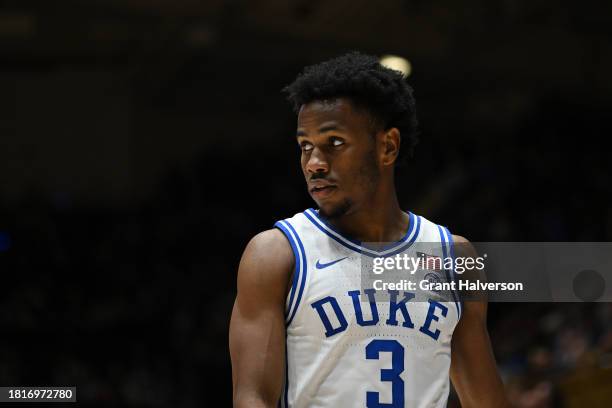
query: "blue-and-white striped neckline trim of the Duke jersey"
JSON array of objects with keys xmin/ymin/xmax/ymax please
[{"xmin": 303, "ymin": 208, "xmax": 421, "ymax": 258}]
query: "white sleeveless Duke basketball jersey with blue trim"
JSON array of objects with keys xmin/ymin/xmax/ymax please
[{"xmin": 275, "ymin": 209, "xmax": 462, "ymax": 408}]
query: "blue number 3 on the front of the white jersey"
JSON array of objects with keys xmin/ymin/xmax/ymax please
[{"xmin": 366, "ymin": 340, "xmax": 404, "ymax": 408}]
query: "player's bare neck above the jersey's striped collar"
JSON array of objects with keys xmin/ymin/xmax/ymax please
[{"xmin": 322, "ymin": 180, "xmax": 409, "ymax": 242}]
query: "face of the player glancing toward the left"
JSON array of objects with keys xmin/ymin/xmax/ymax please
[{"xmin": 297, "ymin": 98, "xmax": 380, "ymax": 218}]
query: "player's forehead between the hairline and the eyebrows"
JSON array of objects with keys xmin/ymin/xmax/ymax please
[{"xmin": 298, "ymin": 98, "xmax": 369, "ymax": 130}]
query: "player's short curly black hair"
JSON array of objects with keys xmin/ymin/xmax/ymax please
[{"xmin": 283, "ymin": 51, "xmax": 418, "ymax": 162}]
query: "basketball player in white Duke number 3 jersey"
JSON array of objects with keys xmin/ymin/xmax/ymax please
[{"xmin": 230, "ymin": 53, "xmax": 507, "ymax": 408}]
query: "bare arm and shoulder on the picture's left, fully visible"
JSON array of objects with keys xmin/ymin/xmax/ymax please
[{"xmin": 229, "ymin": 229, "xmax": 294, "ymax": 407}]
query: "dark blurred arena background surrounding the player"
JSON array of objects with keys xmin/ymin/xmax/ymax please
[{"xmin": 0, "ymin": 0, "xmax": 612, "ymax": 408}]
